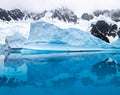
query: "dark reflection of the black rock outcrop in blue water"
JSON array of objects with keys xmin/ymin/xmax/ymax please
[{"xmin": 92, "ymin": 58, "xmax": 120, "ymax": 78}]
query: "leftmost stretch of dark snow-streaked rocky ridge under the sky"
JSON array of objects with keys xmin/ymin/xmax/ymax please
[{"xmin": 0, "ymin": 8, "xmax": 47, "ymax": 21}]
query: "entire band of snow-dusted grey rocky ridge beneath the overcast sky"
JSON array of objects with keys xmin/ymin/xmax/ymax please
[{"xmin": 0, "ymin": 7, "xmax": 120, "ymax": 23}]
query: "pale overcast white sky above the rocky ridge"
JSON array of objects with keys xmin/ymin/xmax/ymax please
[{"xmin": 0, "ymin": 0, "xmax": 120, "ymax": 12}]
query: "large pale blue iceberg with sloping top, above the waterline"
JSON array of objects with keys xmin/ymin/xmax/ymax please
[{"xmin": 23, "ymin": 21, "xmax": 112, "ymax": 50}]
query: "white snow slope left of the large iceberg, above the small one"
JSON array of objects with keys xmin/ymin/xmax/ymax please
[{"xmin": 0, "ymin": 21, "xmax": 30, "ymax": 44}]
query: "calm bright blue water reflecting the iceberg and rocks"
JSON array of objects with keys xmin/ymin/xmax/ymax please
[{"xmin": 0, "ymin": 52, "xmax": 120, "ymax": 95}]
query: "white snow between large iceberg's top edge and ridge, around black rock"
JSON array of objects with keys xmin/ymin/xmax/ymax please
[{"xmin": 41, "ymin": 13, "xmax": 120, "ymax": 43}]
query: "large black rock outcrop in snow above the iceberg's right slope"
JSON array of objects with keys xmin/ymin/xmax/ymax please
[{"xmin": 91, "ymin": 20, "xmax": 118, "ymax": 43}]
